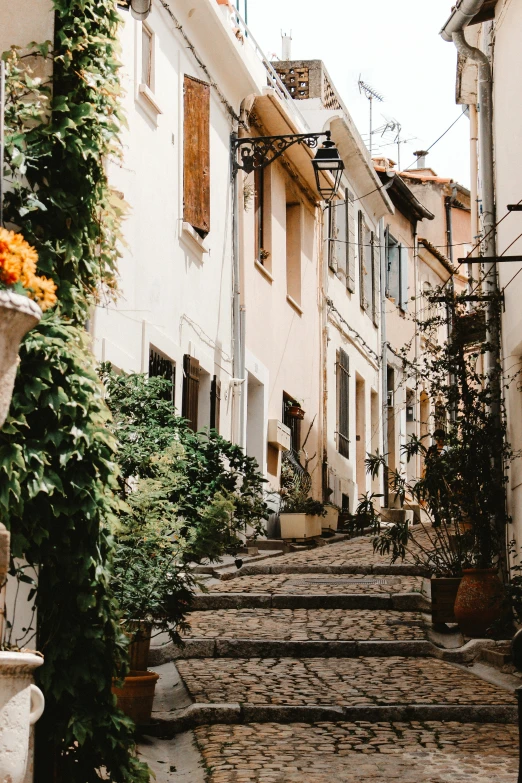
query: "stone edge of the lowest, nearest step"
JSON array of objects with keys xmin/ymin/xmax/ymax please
[{"xmin": 147, "ymin": 704, "xmax": 518, "ymax": 737}]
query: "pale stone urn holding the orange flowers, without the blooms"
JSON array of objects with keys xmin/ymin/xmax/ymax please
[{"xmin": 0, "ymin": 291, "xmax": 42, "ymax": 432}]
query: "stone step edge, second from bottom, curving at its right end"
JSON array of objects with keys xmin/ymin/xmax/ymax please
[{"xmin": 149, "ymin": 639, "xmax": 495, "ymax": 668}]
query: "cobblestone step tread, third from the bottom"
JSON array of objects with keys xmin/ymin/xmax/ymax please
[{"xmin": 183, "ymin": 609, "xmax": 426, "ymax": 641}]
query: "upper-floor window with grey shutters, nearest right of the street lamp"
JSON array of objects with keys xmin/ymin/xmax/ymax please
[{"xmin": 328, "ymin": 189, "xmax": 355, "ymax": 293}]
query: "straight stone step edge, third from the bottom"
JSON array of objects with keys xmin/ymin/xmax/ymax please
[{"xmin": 190, "ymin": 593, "xmax": 431, "ymax": 612}]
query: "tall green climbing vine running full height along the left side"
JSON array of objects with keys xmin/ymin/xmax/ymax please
[{"xmin": 0, "ymin": 0, "xmax": 149, "ymax": 783}]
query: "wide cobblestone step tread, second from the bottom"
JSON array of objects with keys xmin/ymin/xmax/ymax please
[{"xmin": 177, "ymin": 657, "xmax": 515, "ymax": 706}]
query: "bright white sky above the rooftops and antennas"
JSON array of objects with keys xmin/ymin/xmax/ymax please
[{"xmin": 240, "ymin": 0, "xmax": 469, "ymax": 186}]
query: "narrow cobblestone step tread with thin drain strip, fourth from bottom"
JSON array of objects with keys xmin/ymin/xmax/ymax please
[{"xmin": 203, "ymin": 572, "xmax": 422, "ymax": 595}]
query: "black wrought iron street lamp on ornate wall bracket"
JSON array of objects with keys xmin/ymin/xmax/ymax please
[{"xmin": 232, "ymin": 131, "xmax": 344, "ymax": 201}]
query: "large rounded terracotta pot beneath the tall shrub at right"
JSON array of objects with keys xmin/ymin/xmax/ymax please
[{"xmin": 455, "ymin": 568, "xmax": 504, "ymax": 639}]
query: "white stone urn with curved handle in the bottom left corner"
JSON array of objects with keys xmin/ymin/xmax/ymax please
[{"xmin": 0, "ymin": 652, "xmax": 45, "ymax": 783}]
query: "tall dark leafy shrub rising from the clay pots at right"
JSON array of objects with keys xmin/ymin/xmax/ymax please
[{"xmin": 350, "ymin": 291, "xmax": 514, "ymax": 576}]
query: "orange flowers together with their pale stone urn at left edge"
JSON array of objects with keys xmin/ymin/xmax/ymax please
[{"xmin": 0, "ymin": 227, "xmax": 56, "ymax": 426}]
